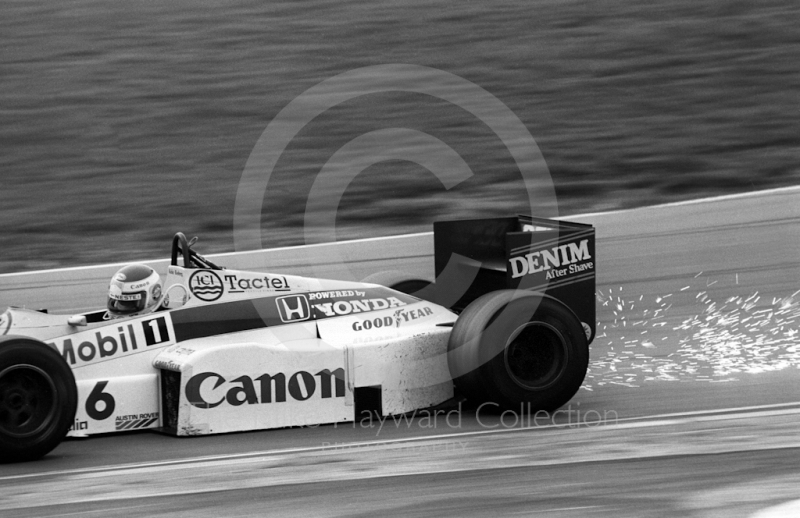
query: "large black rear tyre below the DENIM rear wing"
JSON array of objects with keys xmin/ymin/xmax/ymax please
[{"xmin": 447, "ymin": 290, "xmax": 589, "ymax": 413}]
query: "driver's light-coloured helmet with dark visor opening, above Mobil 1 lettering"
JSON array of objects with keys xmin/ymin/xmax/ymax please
[{"xmin": 108, "ymin": 264, "xmax": 161, "ymax": 316}]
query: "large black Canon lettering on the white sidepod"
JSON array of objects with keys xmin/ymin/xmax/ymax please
[{"xmin": 185, "ymin": 367, "xmax": 345, "ymax": 408}]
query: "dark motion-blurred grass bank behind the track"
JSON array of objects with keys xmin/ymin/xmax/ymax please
[{"xmin": 0, "ymin": 0, "xmax": 800, "ymax": 272}]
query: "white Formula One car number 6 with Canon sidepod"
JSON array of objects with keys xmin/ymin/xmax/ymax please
[{"xmin": 0, "ymin": 216, "xmax": 595, "ymax": 462}]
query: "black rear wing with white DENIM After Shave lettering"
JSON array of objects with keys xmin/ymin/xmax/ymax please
[{"xmin": 433, "ymin": 216, "xmax": 596, "ymax": 337}]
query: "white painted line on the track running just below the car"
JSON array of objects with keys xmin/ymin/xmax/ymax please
[{"xmin": 0, "ymin": 401, "xmax": 800, "ymax": 482}]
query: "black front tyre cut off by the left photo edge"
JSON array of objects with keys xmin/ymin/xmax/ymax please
[{"xmin": 0, "ymin": 336, "xmax": 78, "ymax": 463}]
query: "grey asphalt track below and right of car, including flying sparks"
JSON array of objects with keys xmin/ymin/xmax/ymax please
[{"xmin": 0, "ymin": 189, "xmax": 800, "ymax": 516}]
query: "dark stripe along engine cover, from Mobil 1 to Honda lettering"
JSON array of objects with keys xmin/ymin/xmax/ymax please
[{"xmin": 171, "ymin": 288, "xmax": 419, "ymax": 342}]
